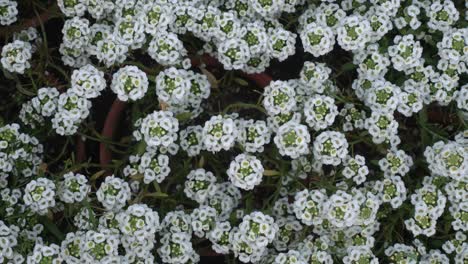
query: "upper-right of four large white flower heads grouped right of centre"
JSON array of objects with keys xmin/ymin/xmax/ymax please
[{"xmin": 304, "ymin": 95, "xmax": 338, "ymax": 131}]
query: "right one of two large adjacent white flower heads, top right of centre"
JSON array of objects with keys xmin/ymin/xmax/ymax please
[{"xmin": 336, "ymin": 15, "xmax": 372, "ymax": 51}]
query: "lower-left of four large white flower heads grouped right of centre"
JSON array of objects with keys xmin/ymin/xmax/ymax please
[{"xmin": 273, "ymin": 122, "xmax": 310, "ymax": 159}]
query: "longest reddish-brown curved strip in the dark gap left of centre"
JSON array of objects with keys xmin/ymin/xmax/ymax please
[{"xmin": 99, "ymin": 99, "xmax": 126, "ymax": 166}]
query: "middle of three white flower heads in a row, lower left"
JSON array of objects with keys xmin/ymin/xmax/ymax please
[{"xmin": 58, "ymin": 172, "xmax": 91, "ymax": 203}]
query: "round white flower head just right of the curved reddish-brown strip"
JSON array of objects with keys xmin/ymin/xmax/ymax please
[{"xmin": 139, "ymin": 111, "xmax": 179, "ymax": 147}]
